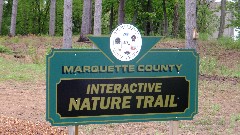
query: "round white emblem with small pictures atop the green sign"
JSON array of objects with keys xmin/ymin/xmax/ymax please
[{"xmin": 110, "ymin": 24, "xmax": 142, "ymax": 61}]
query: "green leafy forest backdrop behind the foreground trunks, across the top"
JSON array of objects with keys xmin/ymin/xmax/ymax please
[{"xmin": 0, "ymin": 0, "xmax": 240, "ymax": 41}]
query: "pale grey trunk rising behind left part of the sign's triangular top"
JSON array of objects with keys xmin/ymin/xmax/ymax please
[{"xmin": 93, "ymin": 0, "xmax": 102, "ymax": 36}]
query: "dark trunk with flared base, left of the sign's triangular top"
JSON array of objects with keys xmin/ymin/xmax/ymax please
[{"xmin": 78, "ymin": 0, "xmax": 92, "ymax": 42}]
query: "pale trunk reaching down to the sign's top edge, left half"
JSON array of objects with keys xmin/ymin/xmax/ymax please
[{"xmin": 63, "ymin": 0, "xmax": 72, "ymax": 49}]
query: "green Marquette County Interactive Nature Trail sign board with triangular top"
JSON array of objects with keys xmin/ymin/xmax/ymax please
[{"xmin": 46, "ymin": 37, "xmax": 199, "ymax": 126}]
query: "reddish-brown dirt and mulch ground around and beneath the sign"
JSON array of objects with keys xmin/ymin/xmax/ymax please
[{"xmin": 0, "ymin": 37, "xmax": 240, "ymax": 135}]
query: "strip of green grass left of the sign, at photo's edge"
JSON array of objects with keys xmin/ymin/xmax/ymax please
[{"xmin": 0, "ymin": 58, "xmax": 46, "ymax": 81}]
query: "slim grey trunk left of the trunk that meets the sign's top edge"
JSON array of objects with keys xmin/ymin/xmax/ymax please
[{"xmin": 49, "ymin": 0, "xmax": 56, "ymax": 36}]
